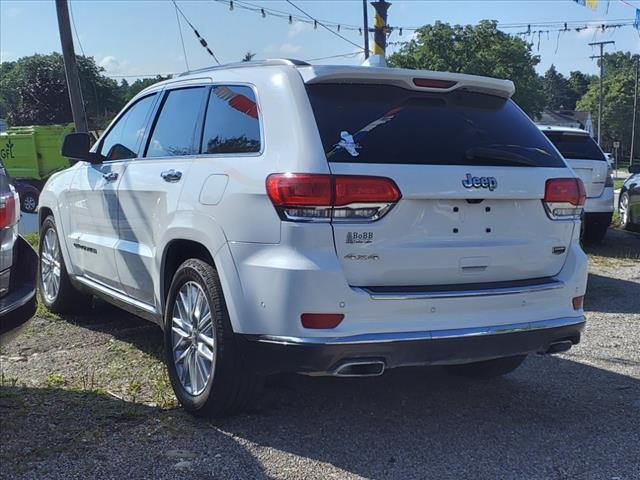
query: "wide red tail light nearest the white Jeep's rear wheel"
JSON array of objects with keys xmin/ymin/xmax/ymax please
[{"xmin": 267, "ymin": 173, "xmax": 401, "ymax": 222}]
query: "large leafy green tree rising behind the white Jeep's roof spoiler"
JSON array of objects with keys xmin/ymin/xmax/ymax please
[{"xmin": 388, "ymin": 20, "xmax": 545, "ymax": 116}]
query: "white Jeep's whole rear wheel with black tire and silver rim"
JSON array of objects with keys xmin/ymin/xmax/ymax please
[{"xmin": 164, "ymin": 259, "xmax": 263, "ymax": 417}]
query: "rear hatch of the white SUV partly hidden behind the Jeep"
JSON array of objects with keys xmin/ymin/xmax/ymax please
[{"xmin": 544, "ymin": 130, "xmax": 609, "ymax": 197}]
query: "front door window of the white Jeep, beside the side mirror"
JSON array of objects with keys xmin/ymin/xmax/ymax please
[{"xmin": 100, "ymin": 93, "xmax": 156, "ymax": 160}]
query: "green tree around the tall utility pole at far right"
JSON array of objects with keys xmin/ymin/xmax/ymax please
[{"xmin": 577, "ymin": 52, "xmax": 640, "ymax": 158}]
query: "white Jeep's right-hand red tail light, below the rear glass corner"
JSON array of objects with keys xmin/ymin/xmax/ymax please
[{"xmin": 543, "ymin": 178, "xmax": 587, "ymax": 220}]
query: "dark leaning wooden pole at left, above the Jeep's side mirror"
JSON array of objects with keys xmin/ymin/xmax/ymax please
[{"xmin": 56, "ymin": 0, "xmax": 89, "ymax": 132}]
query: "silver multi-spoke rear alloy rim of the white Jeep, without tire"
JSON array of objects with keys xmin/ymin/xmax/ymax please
[{"xmin": 171, "ymin": 281, "xmax": 216, "ymax": 396}]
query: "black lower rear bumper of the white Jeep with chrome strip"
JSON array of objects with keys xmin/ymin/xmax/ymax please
[{"xmin": 237, "ymin": 315, "xmax": 585, "ymax": 375}]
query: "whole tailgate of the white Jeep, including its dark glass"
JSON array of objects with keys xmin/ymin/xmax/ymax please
[{"xmin": 307, "ymin": 79, "xmax": 574, "ymax": 287}]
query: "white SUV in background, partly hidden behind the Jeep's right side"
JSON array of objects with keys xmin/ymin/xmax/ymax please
[{"xmin": 539, "ymin": 126, "xmax": 614, "ymax": 243}]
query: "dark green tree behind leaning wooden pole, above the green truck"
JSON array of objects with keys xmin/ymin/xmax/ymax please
[{"xmin": 0, "ymin": 53, "xmax": 123, "ymax": 128}]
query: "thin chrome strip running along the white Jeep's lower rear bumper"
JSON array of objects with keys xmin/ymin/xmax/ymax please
[{"xmin": 252, "ymin": 315, "xmax": 585, "ymax": 345}]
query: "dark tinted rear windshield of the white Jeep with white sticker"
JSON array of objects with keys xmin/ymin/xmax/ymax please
[{"xmin": 307, "ymin": 84, "xmax": 565, "ymax": 167}]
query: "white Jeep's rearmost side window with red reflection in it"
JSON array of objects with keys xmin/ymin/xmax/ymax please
[{"xmin": 202, "ymin": 85, "xmax": 260, "ymax": 153}]
